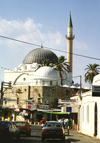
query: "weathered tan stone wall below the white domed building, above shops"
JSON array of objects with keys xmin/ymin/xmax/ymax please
[{"xmin": 3, "ymin": 86, "xmax": 77, "ymax": 107}]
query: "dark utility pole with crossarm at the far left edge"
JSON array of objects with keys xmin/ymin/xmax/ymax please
[{"xmin": 0, "ymin": 81, "xmax": 11, "ymax": 120}]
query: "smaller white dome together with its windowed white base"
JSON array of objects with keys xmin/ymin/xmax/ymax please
[{"xmin": 31, "ymin": 66, "xmax": 61, "ymax": 86}]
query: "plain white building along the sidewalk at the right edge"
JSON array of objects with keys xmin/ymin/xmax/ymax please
[{"xmin": 78, "ymin": 74, "xmax": 100, "ymax": 139}]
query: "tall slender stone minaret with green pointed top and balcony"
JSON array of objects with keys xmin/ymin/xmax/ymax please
[{"xmin": 66, "ymin": 13, "xmax": 74, "ymax": 73}]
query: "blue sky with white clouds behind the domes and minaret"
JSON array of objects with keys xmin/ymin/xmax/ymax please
[{"xmin": 0, "ymin": 0, "xmax": 100, "ymax": 87}]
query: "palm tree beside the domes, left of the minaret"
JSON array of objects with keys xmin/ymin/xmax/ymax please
[{"xmin": 53, "ymin": 56, "xmax": 69, "ymax": 85}]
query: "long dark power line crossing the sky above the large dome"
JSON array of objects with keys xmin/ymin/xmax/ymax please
[{"xmin": 0, "ymin": 35, "xmax": 100, "ymax": 60}]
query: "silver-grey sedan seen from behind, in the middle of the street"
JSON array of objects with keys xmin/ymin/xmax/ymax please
[{"xmin": 42, "ymin": 121, "xmax": 65, "ymax": 141}]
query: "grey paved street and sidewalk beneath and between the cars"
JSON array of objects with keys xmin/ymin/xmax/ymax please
[{"xmin": 0, "ymin": 125, "xmax": 100, "ymax": 143}]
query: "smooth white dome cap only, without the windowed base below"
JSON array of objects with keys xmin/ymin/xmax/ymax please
[{"xmin": 34, "ymin": 66, "xmax": 60, "ymax": 79}]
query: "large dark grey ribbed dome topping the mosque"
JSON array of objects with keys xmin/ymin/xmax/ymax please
[{"xmin": 23, "ymin": 48, "xmax": 58, "ymax": 64}]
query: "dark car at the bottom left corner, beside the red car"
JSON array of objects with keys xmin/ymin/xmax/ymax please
[{"xmin": 0, "ymin": 121, "xmax": 20, "ymax": 141}]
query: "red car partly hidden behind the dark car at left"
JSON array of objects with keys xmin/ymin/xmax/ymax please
[{"xmin": 14, "ymin": 121, "xmax": 31, "ymax": 136}]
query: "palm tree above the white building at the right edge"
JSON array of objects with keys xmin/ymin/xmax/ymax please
[{"xmin": 85, "ymin": 63, "xmax": 100, "ymax": 84}]
